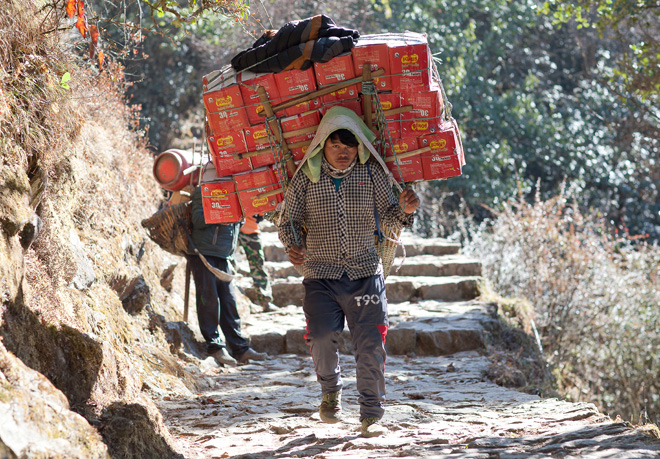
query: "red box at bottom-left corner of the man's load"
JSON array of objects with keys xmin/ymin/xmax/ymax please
[{"xmin": 201, "ymin": 179, "xmax": 243, "ymax": 224}]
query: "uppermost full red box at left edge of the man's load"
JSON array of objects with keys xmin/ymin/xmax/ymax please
[{"xmin": 203, "ymin": 85, "xmax": 248, "ymax": 136}]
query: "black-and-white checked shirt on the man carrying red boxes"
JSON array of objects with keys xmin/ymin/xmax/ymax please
[{"xmin": 279, "ymin": 160, "xmax": 414, "ymax": 280}]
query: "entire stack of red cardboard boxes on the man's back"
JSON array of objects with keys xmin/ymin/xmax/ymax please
[{"xmin": 202, "ymin": 32, "xmax": 465, "ymax": 223}]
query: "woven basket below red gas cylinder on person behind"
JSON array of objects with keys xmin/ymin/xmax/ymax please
[{"xmin": 142, "ymin": 202, "xmax": 192, "ymax": 255}]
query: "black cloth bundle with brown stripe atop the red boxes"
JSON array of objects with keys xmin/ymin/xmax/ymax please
[{"xmin": 231, "ymin": 14, "xmax": 360, "ymax": 73}]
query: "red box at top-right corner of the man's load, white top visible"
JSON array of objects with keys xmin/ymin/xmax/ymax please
[{"xmin": 389, "ymin": 32, "xmax": 432, "ymax": 92}]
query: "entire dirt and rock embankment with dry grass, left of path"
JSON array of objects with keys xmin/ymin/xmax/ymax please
[{"xmin": 0, "ymin": 2, "xmax": 211, "ymax": 457}]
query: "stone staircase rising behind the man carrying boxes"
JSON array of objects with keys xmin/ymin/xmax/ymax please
[{"xmin": 237, "ymin": 226, "xmax": 499, "ymax": 356}]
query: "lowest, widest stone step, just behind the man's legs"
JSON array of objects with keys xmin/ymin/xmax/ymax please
[{"xmin": 244, "ymin": 301, "xmax": 499, "ymax": 356}]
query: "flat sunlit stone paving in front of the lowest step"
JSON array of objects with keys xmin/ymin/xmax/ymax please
[{"xmin": 158, "ymin": 351, "xmax": 660, "ymax": 459}]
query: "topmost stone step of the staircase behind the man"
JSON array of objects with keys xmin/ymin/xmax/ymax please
[{"xmin": 261, "ymin": 231, "xmax": 461, "ymax": 262}]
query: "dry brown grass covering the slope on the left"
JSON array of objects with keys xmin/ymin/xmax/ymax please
[{"xmin": 0, "ymin": 1, "xmax": 196, "ymax": 409}]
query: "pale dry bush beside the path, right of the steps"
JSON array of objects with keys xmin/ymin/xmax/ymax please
[{"xmin": 466, "ymin": 188, "xmax": 660, "ymax": 423}]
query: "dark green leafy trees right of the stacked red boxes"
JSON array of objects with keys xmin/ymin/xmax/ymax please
[{"xmin": 368, "ymin": 0, "xmax": 660, "ymax": 243}]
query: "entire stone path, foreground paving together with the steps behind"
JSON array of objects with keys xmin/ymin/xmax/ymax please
[{"xmin": 157, "ymin": 233, "xmax": 660, "ymax": 459}]
